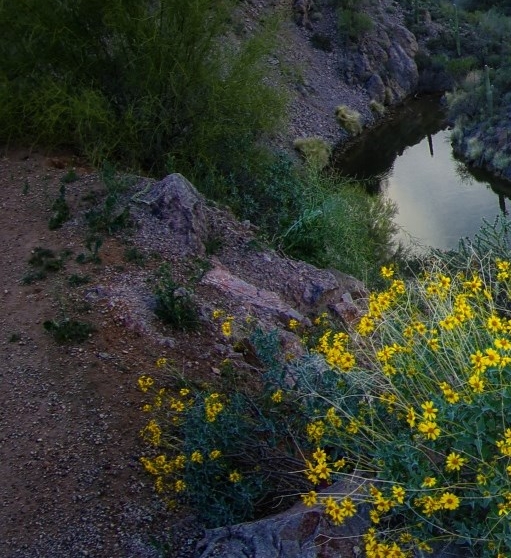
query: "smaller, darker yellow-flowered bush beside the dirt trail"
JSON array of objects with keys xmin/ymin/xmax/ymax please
[{"xmin": 138, "ymin": 331, "xmax": 310, "ymax": 527}]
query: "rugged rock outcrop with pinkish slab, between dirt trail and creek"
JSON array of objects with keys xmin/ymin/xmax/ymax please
[{"xmin": 94, "ymin": 174, "xmax": 368, "ymax": 354}]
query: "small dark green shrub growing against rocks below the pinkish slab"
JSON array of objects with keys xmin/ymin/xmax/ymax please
[{"xmin": 154, "ymin": 264, "xmax": 199, "ymax": 330}]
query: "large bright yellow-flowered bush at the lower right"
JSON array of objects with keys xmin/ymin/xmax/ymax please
[{"xmin": 296, "ymin": 258, "xmax": 511, "ymax": 557}]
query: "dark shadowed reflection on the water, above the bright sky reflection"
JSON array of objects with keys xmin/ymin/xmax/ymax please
[{"xmin": 334, "ymin": 97, "xmax": 445, "ymax": 192}]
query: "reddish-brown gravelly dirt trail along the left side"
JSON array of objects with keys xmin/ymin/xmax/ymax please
[{"xmin": 0, "ymin": 152, "xmax": 204, "ymax": 558}]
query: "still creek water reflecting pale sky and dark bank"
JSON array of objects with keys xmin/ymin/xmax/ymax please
[{"xmin": 335, "ymin": 98, "xmax": 511, "ymax": 249}]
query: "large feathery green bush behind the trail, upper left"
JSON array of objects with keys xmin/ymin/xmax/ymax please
[{"xmin": 0, "ymin": 0, "xmax": 285, "ymax": 179}]
